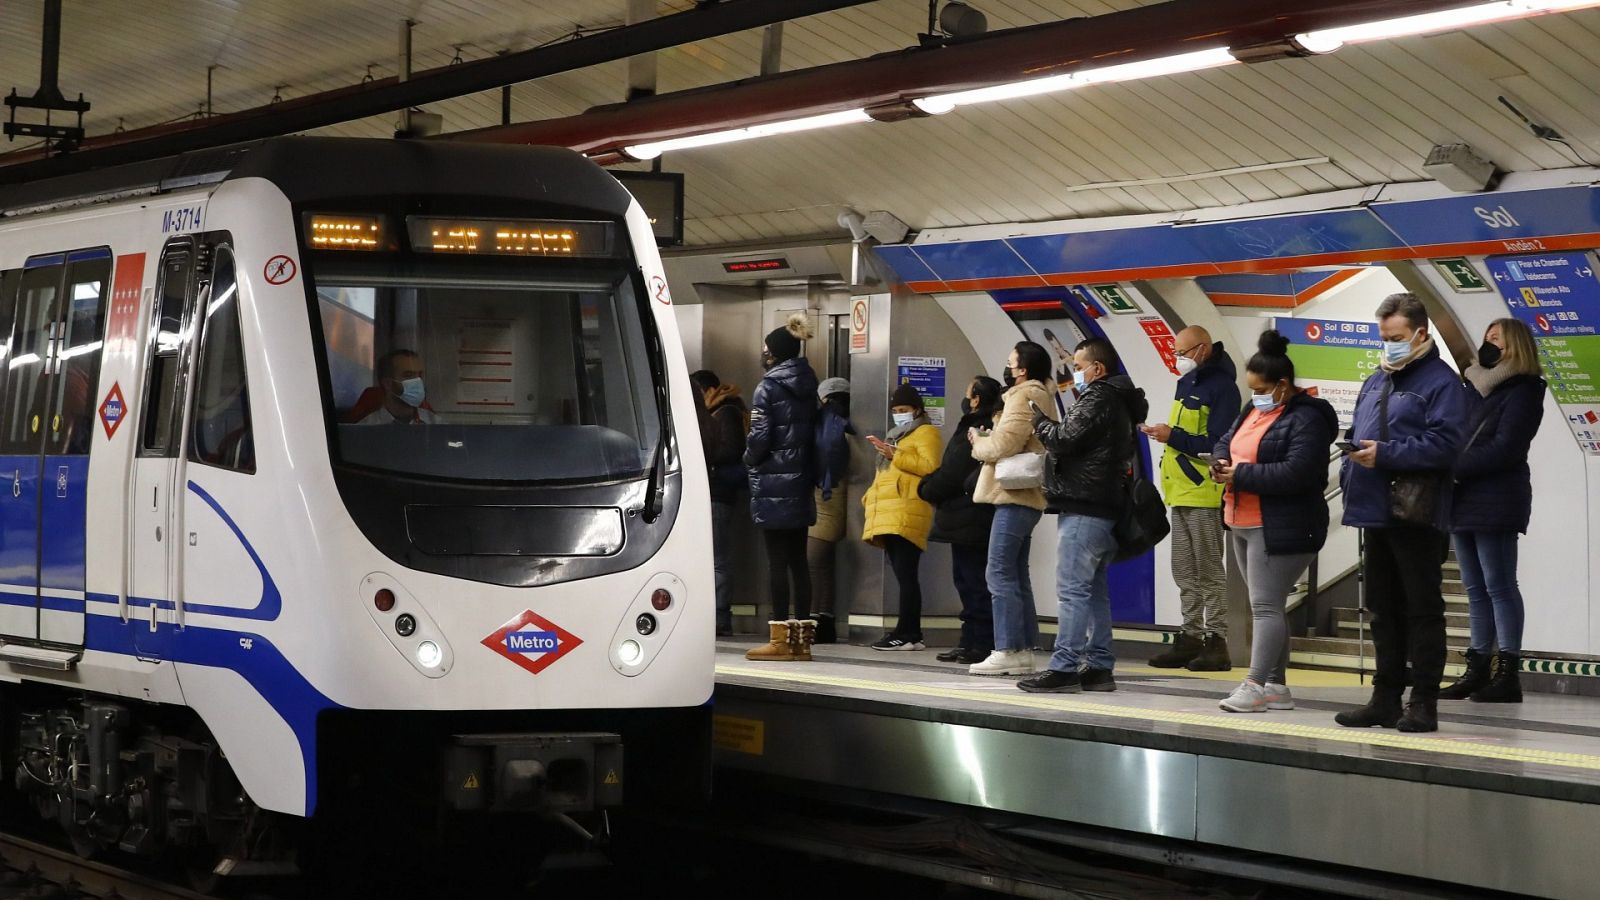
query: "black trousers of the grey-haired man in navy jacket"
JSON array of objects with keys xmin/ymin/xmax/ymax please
[{"xmin": 1366, "ymin": 527, "xmax": 1450, "ymax": 701}]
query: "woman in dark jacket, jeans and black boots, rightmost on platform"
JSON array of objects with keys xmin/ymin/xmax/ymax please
[{"xmin": 1438, "ymin": 319, "xmax": 1544, "ymax": 703}]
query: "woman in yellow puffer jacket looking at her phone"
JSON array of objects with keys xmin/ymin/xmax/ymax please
[{"xmin": 861, "ymin": 384, "xmax": 942, "ymax": 650}]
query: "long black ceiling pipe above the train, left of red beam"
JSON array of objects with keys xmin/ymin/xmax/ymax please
[{"xmin": 0, "ymin": 0, "xmax": 874, "ymax": 184}]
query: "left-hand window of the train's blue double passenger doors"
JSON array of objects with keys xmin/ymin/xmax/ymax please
[{"xmin": 0, "ymin": 256, "xmax": 62, "ymax": 453}]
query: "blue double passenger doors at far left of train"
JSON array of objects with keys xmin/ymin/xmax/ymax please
[{"xmin": 0, "ymin": 248, "xmax": 112, "ymax": 645}]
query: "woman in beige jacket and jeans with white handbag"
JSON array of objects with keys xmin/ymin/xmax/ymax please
[{"xmin": 968, "ymin": 341, "xmax": 1059, "ymax": 676}]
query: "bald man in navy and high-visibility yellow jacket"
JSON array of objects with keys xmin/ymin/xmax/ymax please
[{"xmin": 1142, "ymin": 325, "xmax": 1240, "ymax": 671}]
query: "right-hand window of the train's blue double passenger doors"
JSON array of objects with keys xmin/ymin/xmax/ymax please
[{"xmin": 45, "ymin": 253, "xmax": 110, "ymax": 453}]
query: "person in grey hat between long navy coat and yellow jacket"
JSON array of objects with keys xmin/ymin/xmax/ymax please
[{"xmin": 805, "ymin": 378, "xmax": 856, "ymax": 644}]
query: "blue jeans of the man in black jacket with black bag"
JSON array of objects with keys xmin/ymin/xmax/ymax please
[{"xmin": 1050, "ymin": 512, "xmax": 1117, "ymax": 673}]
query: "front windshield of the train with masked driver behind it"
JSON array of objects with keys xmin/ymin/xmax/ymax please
[{"xmin": 314, "ymin": 259, "xmax": 661, "ymax": 482}]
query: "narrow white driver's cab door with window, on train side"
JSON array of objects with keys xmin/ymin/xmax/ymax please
[{"xmin": 128, "ymin": 239, "xmax": 200, "ymax": 658}]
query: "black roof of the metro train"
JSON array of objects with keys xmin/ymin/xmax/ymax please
[{"xmin": 0, "ymin": 138, "xmax": 632, "ymax": 216}]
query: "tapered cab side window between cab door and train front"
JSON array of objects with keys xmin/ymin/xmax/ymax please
[{"xmin": 189, "ymin": 247, "xmax": 256, "ymax": 472}]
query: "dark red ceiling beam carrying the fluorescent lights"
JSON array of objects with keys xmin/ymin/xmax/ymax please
[{"xmin": 438, "ymin": 0, "xmax": 1516, "ymax": 162}]
